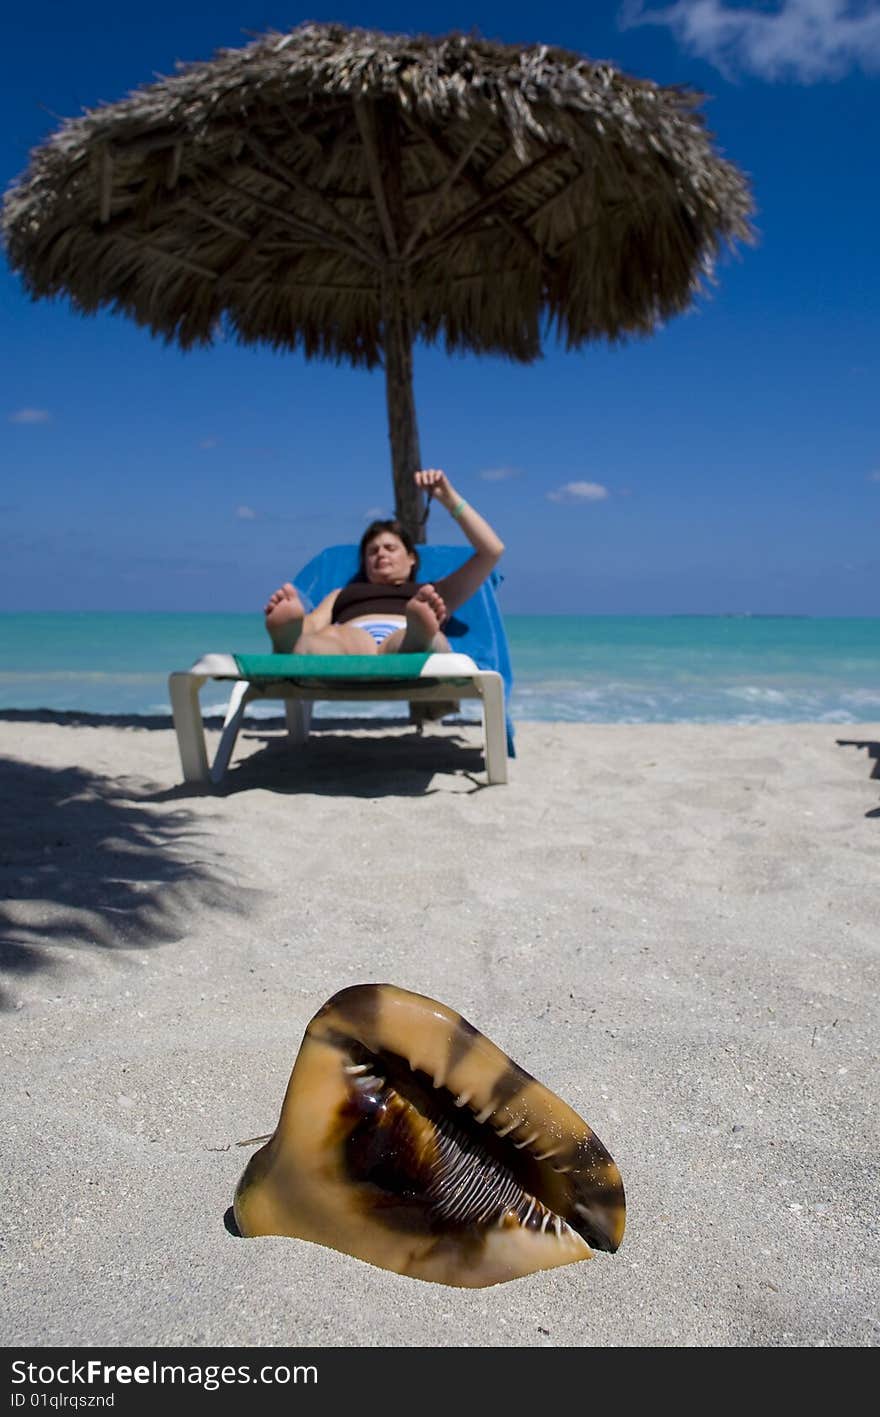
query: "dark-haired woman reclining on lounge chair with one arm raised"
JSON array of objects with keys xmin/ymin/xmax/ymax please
[{"xmin": 265, "ymin": 468, "xmax": 504, "ymax": 655}]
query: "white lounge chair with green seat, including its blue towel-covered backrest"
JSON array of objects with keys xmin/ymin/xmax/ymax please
[{"xmin": 169, "ymin": 546, "xmax": 514, "ymax": 784}]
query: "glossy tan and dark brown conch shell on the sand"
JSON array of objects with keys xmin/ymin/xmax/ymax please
[{"xmin": 234, "ymin": 983, "xmax": 626, "ymax": 1288}]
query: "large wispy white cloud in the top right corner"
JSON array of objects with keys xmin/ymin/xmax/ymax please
[{"xmin": 621, "ymin": 0, "xmax": 880, "ymax": 84}]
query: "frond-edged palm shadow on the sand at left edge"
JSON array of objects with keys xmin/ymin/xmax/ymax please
[{"xmin": 0, "ymin": 758, "xmax": 251, "ymax": 1007}]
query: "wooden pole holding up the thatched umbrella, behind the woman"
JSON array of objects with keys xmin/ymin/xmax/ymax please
[{"xmin": 383, "ymin": 269, "xmax": 427, "ymax": 541}]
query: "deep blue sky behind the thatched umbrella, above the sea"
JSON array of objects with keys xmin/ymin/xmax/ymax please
[{"xmin": 0, "ymin": 0, "xmax": 880, "ymax": 615}]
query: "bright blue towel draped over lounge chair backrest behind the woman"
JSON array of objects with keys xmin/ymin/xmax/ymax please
[{"xmin": 293, "ymin": 544, "xmax": 516, "ymax": 758}]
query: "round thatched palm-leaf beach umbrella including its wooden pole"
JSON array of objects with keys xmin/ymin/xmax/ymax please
[{"xmin": 3, "ymin": 24, "xmax": 751, "ymax": 527}]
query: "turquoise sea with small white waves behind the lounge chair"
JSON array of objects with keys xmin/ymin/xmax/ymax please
[{"xmin": 0, "ymin": 612, "xmax": 880, "ymax": 723}]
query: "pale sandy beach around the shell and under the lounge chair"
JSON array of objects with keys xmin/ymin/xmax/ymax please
[{"xmin": 0, "ymin": 711, "xmax": 880, "ymax": 1348}]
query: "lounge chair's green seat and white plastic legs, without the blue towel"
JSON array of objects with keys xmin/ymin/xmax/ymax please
[{"xmin": 169, "ymin": 653, "xmax": 507, "ymax": 784}]
